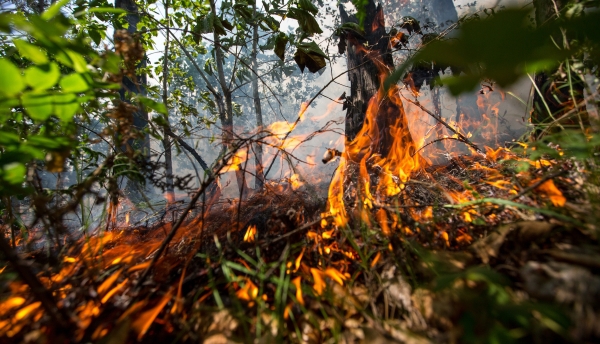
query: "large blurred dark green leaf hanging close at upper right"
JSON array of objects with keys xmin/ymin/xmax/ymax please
[{"xmin": 386, "ymin": 10, "xmax": 600, "ymax": 95}]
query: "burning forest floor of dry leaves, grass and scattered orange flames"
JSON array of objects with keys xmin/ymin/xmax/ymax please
[{"xmin": 0, "ymin": 150, "xmax": 600, "ymax": 343}]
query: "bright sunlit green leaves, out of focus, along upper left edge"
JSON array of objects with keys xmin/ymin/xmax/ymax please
[{"xmin": 0, "ymin": 1, "xmax": 120, "ymax": 196}]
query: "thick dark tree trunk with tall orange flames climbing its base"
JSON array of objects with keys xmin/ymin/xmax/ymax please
[{"xmin": 328, "ymin": 0, "xmax": 424, "ymax": 227}]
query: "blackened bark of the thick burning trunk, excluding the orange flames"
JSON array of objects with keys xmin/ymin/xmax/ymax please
[{"xmin": 338, "ymin": 0, "xmax": 413, "ymax": 156}]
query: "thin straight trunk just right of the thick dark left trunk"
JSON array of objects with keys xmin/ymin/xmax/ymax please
[{"xmin": 162, "ymin": 0, "xmax": 175, "ymax": 203}]
